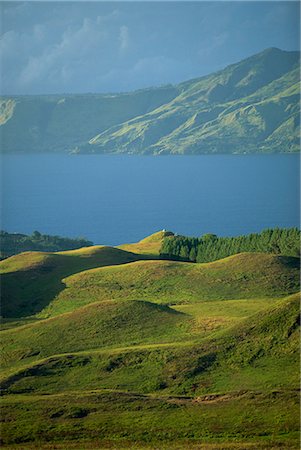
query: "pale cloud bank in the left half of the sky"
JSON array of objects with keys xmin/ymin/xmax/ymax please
[{"xmin": 0, "ymin": 9, "xmax": 130, "ymax": 93}]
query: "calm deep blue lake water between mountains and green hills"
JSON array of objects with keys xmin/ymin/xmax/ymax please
[{"xmin": 1, "ymin": 154, "xmax": 300, "ymax": 245}]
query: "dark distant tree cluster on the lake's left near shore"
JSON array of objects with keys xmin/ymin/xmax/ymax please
[{"xmin": 0, "ymin": 231, "xmax": 93, "ymax": 259}]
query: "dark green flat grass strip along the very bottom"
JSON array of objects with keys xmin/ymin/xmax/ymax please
[{"xmin": 2, "ymin": 391, "xmax": 297, "ymax": 449}]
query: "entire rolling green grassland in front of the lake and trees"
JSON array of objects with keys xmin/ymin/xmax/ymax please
[{"xmin": 0, "ymin": 231, "xmax": 300, "ymax": 450}]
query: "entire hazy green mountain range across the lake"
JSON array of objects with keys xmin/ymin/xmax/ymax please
[{"xmin": 0, "ymin": 48, "xmax": 300, "ymax": 155}]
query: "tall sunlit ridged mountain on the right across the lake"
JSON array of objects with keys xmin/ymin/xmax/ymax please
[{"xmin": 90, "ymin": 49, "xmax": 300, "ymax": 154}]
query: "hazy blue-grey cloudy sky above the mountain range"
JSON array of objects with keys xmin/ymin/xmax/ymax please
[{"xmin": 0, "ymin": 1, "xmax": 300, "ymax": 94}]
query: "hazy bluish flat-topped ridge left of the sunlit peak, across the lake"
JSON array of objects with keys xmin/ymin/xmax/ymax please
[{"xmin": 0, "ymin": 86, "xmax": 178, "ymax": 153}]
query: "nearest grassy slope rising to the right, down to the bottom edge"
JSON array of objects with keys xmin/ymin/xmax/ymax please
[{"xmin": 3, "ymin": 295, "xmax": 299, "ymax": 449}]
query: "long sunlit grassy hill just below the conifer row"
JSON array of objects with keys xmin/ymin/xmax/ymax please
[{"xmin": 41, "ymin": 253, "xmax": 299, "ymax": 317}]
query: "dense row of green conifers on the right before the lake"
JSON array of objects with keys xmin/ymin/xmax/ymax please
[{"xmin": 160, "ymin": 228, "xmax": 300, "ymax": 262}]
